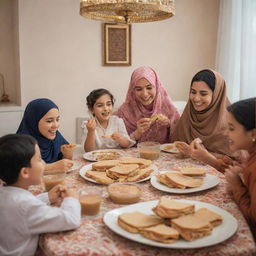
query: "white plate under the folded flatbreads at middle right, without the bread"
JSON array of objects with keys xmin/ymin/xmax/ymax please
[{"xmin": 150, "ymin": 172, "xmax": 220, "ymax": 194}]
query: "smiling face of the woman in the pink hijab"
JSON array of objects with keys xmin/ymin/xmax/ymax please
[{"xmin": 134, "ymin": 78, "xmax": 156, "ymax": 106}]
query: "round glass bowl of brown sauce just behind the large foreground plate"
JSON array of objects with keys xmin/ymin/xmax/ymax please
[{"xmin": 108, "ymin": 183, "xmax": 141, "ymax": 204}]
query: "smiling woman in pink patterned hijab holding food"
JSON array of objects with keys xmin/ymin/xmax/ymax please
[{"xmin": 117, "ymin": 66, "xmax": 180, "ymax": 143}]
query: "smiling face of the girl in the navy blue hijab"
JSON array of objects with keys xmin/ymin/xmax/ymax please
[{"xmin": 38, "ymin": 108, "xmax": 60, "ymax": 140}]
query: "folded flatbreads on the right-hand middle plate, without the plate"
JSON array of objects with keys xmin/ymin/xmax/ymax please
[{"xmin": 156, "ymin": 169, "xmax": 205, "ymax": 189}]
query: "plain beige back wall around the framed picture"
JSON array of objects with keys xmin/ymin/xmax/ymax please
[{"xmin": 19, "ymin": 0, "xmax": 219, "ymax": 142}]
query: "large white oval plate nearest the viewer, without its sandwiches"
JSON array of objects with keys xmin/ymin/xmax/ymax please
[{"xmin": 103, "ymin": 200, "xmax": 238, "ymax": 249}]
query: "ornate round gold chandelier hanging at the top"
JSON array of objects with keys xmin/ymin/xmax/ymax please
[{"xmin": 80, "ymin": 0, "xmax": 175, "ymax": 23}]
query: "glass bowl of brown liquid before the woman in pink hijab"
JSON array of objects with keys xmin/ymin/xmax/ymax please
[{"xmin": 137, "ymin": 141, "xmax": 160, "ymax": 160}]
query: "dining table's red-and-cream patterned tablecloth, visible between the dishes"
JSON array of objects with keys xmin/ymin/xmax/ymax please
[{"xmin": 30, "ymin": 148, "xmax": 256, "ymax": 256}]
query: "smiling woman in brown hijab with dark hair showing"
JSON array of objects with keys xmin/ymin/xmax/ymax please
[{"xmin": 173, "ymin": 69, "xmax": 231, "ymax": 171}]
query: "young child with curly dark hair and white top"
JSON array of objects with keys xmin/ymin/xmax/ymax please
[{"xmin": 82, "ymin": 89, "xmax": 135, "ymax": 152}]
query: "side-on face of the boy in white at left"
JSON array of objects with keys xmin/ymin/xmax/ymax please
[{"xmin": 27, "ymin": 145, "xmax": 45, "ymax": 185}]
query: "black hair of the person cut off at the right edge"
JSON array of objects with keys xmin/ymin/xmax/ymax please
[{"xmin": 227, "ymin": 97, "xmax": 256, "ymax": 131}]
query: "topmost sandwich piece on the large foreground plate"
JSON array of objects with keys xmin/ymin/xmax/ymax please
[{"xmin": 152, "ymin": 196, "xmax": 195, "ymax": 218}]
